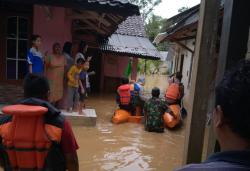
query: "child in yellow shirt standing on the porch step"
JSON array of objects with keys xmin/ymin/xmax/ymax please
[{"xmin": 67, "ymin": 58, "xmax": 85, "ymax": 112}]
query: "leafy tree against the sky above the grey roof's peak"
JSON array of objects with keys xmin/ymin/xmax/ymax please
[{"xmin": 129, "ymin": 0, "xmax": 162, "ymax": 21}]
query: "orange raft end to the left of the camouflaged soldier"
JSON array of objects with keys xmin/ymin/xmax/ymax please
[{"xmin": 112, "ymin": 108, "xmax": 143, "ymax": 124}]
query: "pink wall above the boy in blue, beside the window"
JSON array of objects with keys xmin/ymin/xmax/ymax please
[{"xmin": 33, "ymin": 5, "xmax": 72, "ymax": 52}]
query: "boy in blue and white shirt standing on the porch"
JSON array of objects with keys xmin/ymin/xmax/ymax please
[{"xmin": 27, "ymin": 35, "xmax": 46, "ymax": 75}]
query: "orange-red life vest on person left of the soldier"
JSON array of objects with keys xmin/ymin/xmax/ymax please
[{"xmin": 118, "ymin": 84, "xmax": 131, "ymax": 105}]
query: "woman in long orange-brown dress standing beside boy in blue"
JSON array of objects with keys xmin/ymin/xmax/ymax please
[{"xmin": 45, "ymin": 43, "xmax": 67, "ymax": 106}]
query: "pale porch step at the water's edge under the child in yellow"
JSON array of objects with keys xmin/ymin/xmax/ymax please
[{"xmin": 62, "ymin": 109, "xmax": 97, "ymax": 127}]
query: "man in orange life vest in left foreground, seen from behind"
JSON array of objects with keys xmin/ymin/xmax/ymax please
[{"xmin": 0, "ymin": 74, "xmax": 79, "ymax": 171}]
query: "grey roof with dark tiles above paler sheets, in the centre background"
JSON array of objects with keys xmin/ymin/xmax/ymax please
[{"xmin": 101, "ymin": 16, "xmax": 161, "ymax": 60}]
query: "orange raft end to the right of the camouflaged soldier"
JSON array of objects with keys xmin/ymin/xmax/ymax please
[{"xmin": 163, "ymin": 104, "xmax": 181, "ymax": 128}]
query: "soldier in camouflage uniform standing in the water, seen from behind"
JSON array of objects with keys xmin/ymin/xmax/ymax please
[{"xmin": 144, "ymin": 88, "xmax": 168, "ymax": 132}]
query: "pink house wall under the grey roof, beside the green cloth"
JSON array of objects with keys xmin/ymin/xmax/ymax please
[{"xmin": 101, "ymin": 54, "xmax": 138, "ymax": 92}]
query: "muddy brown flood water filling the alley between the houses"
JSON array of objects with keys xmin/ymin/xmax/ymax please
[{"xmin": 73, "ymin": 76, "xmax": 184, "ymax": 171}]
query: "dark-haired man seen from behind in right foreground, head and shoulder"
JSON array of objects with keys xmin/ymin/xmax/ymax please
[{"xmin": 178, "ymin": 60, "xmax": 250, "ymax": 171}]
